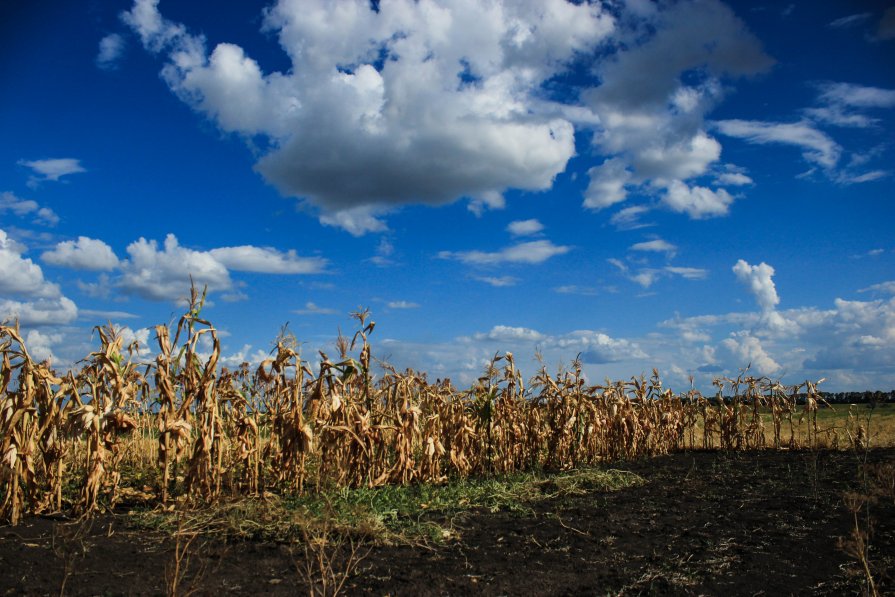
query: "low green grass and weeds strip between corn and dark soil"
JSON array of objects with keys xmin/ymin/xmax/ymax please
[{"xmin": 131, "ymin": 468, "xmax": 644, "ymax": 543}]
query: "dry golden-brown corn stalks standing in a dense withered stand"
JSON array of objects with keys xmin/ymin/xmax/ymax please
[{"xmin": 0, "ymin": 289, "xmax": 864, "ymax": 524}]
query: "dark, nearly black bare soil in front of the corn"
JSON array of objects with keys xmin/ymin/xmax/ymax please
[{"xmin": 0, "ymin": 449, "xmax": 895, "ymax": 596}]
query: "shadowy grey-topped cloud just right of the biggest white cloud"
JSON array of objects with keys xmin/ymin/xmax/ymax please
[{"xmin": 582, "ymin": 0, "xmax": 772, "ymax": 218}]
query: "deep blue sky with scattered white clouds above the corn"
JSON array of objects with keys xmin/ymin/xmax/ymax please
[{"xmin": 0, "ymin": 0, "xmax": 895, "ymax": 390}]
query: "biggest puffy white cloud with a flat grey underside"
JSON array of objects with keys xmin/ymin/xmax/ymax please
[{"xmin": 124, "ymin": 0, "xmax": 614, "ymax": 234}]
